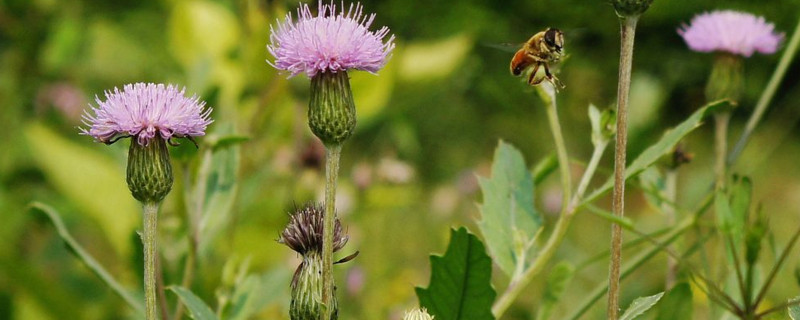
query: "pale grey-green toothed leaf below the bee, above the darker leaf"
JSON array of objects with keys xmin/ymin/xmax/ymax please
[{"xmin": 478, "ymin": 140, "xmax": 542, "ymax": 276}]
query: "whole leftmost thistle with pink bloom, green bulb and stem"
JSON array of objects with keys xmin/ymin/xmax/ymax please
[{"xmin": 81, "ymin": 83, "xmax": 212, "ymax": 320}]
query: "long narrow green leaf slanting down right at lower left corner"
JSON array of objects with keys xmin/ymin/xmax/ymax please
[{"xmin": 31, "ymin": 202, "xmax": 144, "ymax": 315}]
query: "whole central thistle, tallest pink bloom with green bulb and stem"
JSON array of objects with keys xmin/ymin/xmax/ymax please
[{"xmin": 267, "ymin": 1, "xmax": 394, "ymax": 320}]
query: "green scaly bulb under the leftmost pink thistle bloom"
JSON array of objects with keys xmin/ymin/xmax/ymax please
[{"xmin": 127, "ymin": 139, "xmax": 173, "ymax": 203}]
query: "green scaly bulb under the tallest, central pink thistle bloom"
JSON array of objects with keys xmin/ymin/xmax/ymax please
[{"xmin": 308, "ymin": 71, "xmax": 356, "ymax": 145}]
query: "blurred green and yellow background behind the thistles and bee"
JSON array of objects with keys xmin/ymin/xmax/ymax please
[{"xmin": 0, "ymin": 0, "xmax": 800, "ymax": 319}]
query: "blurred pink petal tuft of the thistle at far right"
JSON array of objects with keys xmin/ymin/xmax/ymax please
[{"xmin": 678, "ymin": 10, "xmax": 783, "ymax": 57}]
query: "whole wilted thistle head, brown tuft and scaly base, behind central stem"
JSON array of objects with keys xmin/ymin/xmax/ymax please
[{"xmin": 278, "ymin": 205, "xmax": 349, "ymax": 320}]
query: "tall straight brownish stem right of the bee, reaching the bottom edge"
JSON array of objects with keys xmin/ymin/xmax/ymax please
[{"xmin": 606, "ymin": 16, "xmax": 639, "ymax": 320}]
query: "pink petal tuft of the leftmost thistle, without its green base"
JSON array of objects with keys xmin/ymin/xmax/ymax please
[{"xmin": 81, "ymin": 83, "xmax": 212, "ymax": 146}]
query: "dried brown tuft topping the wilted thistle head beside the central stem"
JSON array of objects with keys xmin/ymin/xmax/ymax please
[{"xmin": 278, "ymin": 204, "xmax": 349, "ymax": 256}]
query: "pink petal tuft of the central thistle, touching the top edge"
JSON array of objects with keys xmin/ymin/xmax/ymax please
[{"xmin": 267, "ymin": 0, "xmax": 394, "ymax": 78}]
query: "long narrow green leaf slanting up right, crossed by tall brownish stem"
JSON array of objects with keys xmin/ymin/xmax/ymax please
[{"xmin": 581, "ymin": 100, "xmax": 729, "ymax": 204}]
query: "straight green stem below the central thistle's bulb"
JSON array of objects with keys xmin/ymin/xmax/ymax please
[{"xmin": 322, "ymin": 144, "xmax": 342, "ymax": 320}]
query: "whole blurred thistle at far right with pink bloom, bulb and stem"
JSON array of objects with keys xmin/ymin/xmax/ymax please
[{"xmin": 678, "ymin": 10, "xmax": 783, "ymax": 189}]
